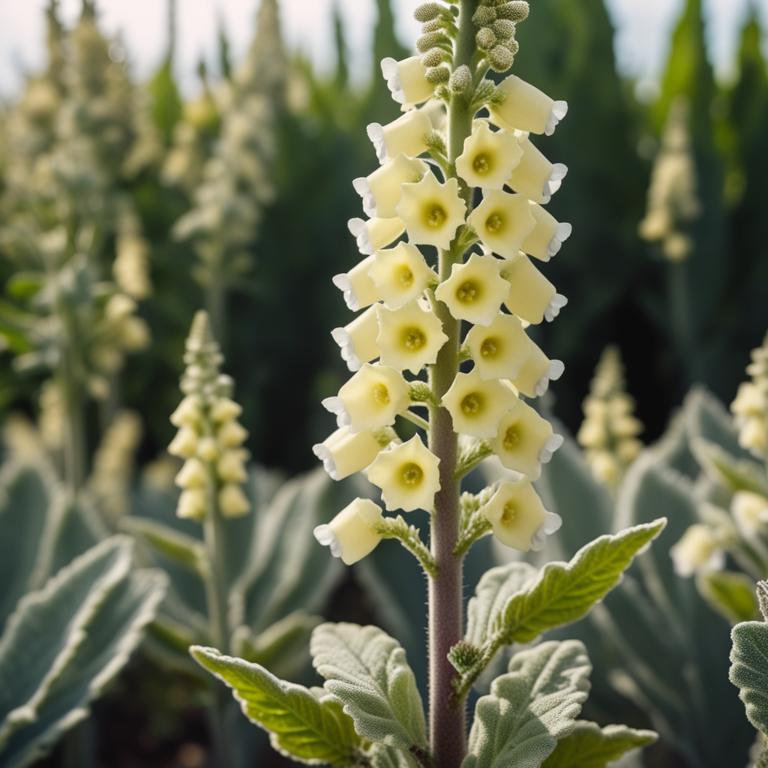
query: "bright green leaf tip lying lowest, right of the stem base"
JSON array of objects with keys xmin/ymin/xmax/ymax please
[{"xmin": 542, "ymin": 721, "xmax": 657, "ymax": 768}]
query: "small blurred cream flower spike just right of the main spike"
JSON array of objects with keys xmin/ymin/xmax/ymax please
[{"xmin": 577, "ymin": 347, "xmax": 643, "ymax": 488}]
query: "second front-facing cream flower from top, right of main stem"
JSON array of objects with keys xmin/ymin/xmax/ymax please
[{"xmin": 467, "ymin": 190, "xmax": 536, "ymax": 257}]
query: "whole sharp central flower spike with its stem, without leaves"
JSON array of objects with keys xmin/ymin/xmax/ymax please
[{"xmin": 315, "ymin": 0, "xmax": 571, "ymax": 768}]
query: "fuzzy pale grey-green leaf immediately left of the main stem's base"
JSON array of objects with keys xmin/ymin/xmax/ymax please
[{"xmin": 310, "ymin": 624, "xmax": 427, "ymax": 752}]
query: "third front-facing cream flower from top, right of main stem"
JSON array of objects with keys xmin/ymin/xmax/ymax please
[{"xmin": 435, "ymin": 253, "xmax": 509, "ymax": 325}]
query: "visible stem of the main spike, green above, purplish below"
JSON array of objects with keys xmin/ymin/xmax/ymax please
[{"xmin": 429, "ymin": 0, "xmax": 477, "ymax": 768}]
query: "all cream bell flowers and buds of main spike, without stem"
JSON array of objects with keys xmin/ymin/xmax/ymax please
[{"xmin": 314, "ymin": 2, "xmax": 571, "ymax": 563}]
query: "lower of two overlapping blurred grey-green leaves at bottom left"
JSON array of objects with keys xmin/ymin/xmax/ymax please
[{"xmin": 2, "ymin": 570, "xmax": 166, "ymax": 768}]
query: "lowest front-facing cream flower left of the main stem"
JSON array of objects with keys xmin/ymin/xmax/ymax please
[{"xmin": 366, "ymin": 435, "xmax": 440, "ymax": 512}]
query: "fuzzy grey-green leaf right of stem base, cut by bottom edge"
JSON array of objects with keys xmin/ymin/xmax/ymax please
[{"xmin": 462, "ymin": 640, "xmax": 592, "ymax": 768}]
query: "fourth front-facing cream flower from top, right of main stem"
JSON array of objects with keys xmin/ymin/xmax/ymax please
[{"xmin": 464, "ymin": 314, "xmax": 533, "ymax": 380}]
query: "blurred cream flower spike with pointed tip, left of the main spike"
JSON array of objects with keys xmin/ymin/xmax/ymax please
[{"xmin": 168, "ymin": 312, "xmax": 250, "ymax": 520}]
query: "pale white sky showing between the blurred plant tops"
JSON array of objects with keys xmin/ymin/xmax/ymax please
[{"xmin": 0, "ymin": 0, "xmax": 768, "ymax": 96}]
